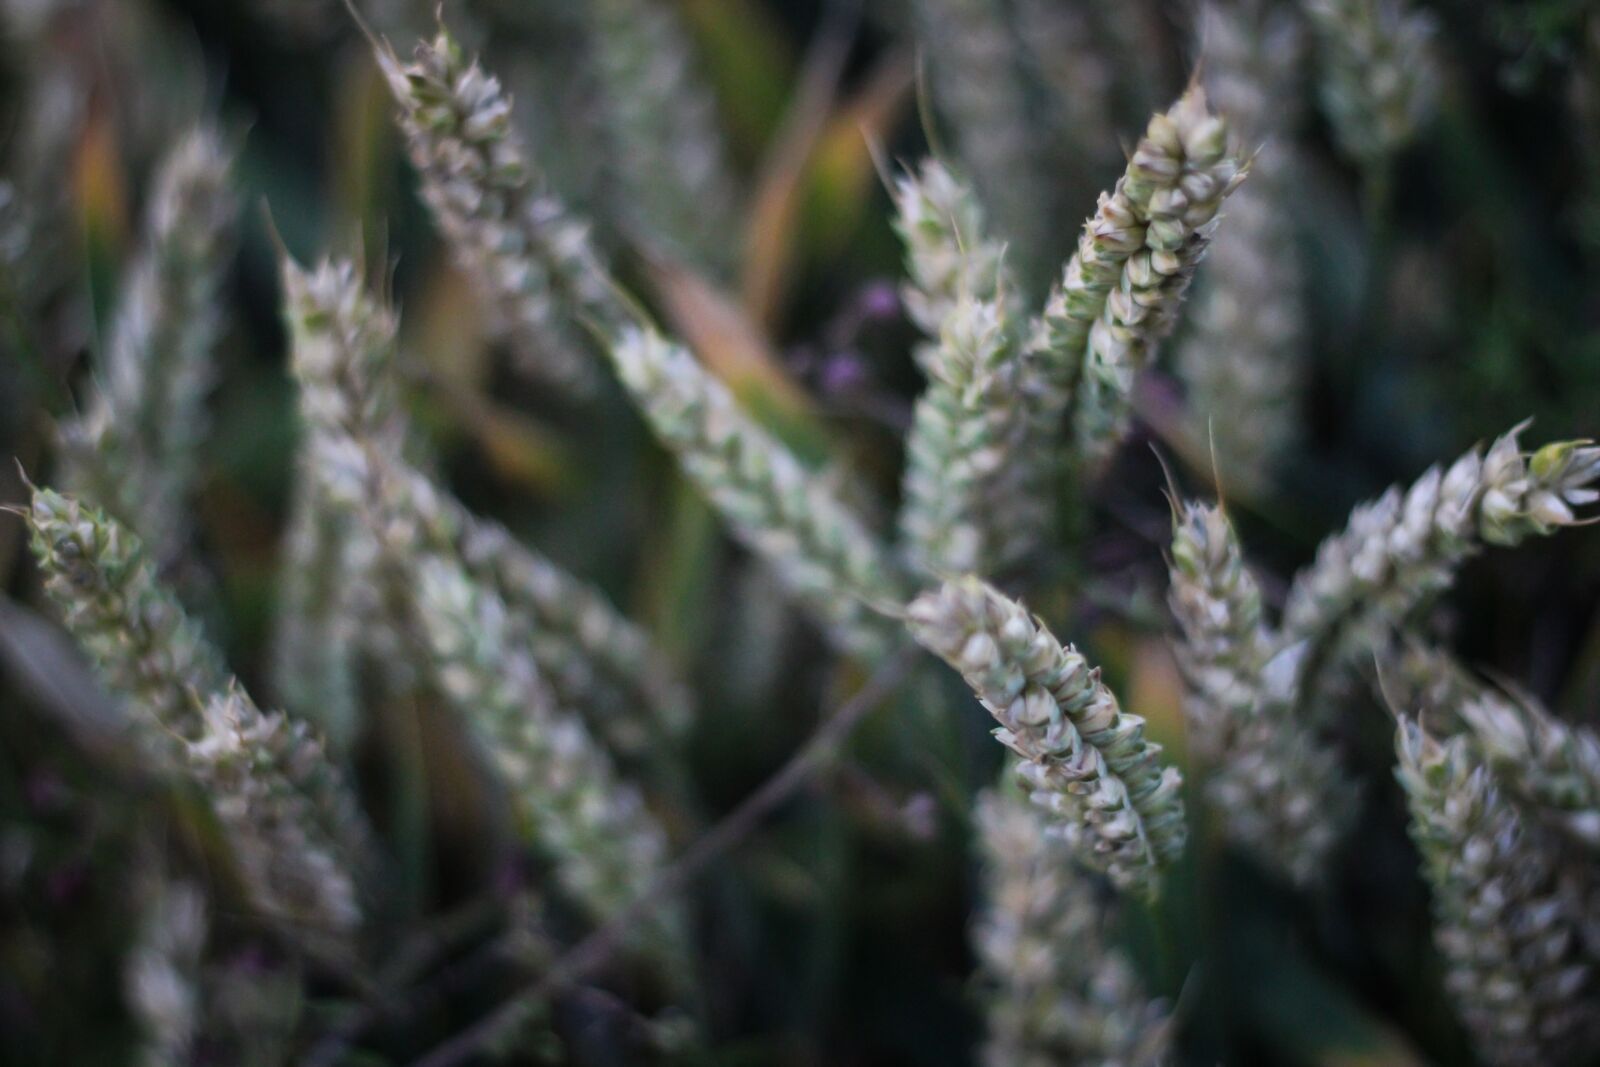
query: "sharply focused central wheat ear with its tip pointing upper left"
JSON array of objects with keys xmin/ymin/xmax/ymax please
[{"xmin": 907, "ymin": 577, "xmax": 1187, "ymax": 896}]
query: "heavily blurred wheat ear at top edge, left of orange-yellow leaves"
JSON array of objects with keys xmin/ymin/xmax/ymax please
[{"xmin": 586, "ymin": 0, "xmax": 739, "ymax": 275}]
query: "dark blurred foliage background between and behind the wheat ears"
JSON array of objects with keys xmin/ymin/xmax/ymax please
[{"xmin": 0, "ymin": 0, "xmax": 1600, "ymax": 1065}]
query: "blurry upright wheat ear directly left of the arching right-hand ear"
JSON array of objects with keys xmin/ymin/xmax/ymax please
[{"xmin": 1168, "ymin": 502, "xmax": 1357, "ymax": 885}]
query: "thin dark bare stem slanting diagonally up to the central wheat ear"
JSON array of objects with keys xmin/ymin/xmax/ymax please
[{"xmin": 400, "ymin": 648, "xmax": 914, "ymax": 1067}]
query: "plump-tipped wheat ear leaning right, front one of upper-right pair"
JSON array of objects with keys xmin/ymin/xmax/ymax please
[{"xmin": 1075, "ymin": 85, "xmax": 1250, "ymax": 469}]
